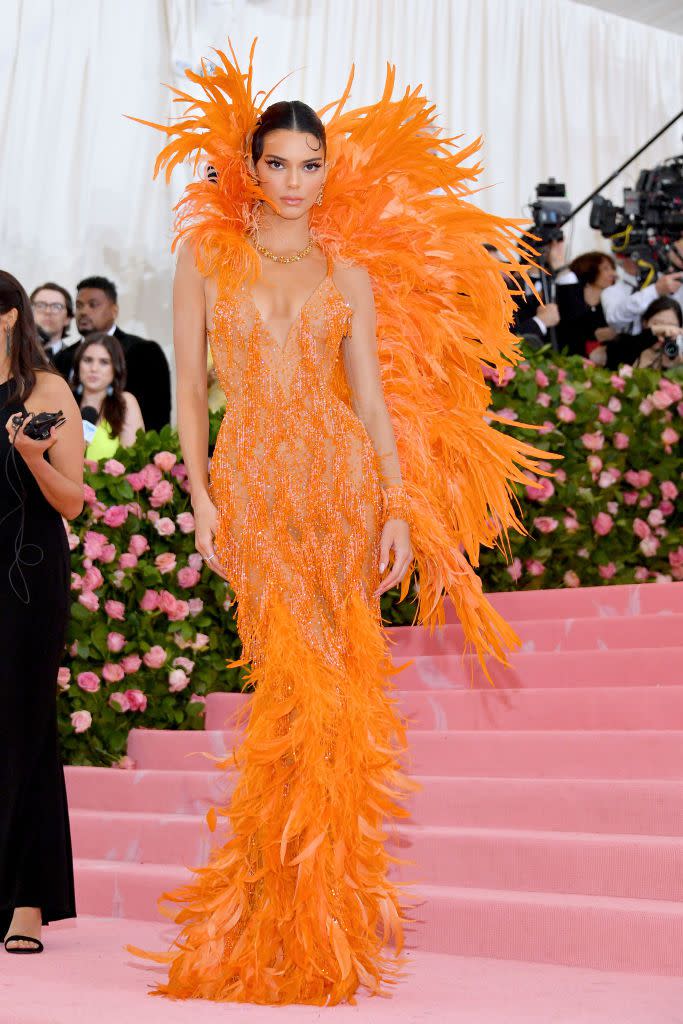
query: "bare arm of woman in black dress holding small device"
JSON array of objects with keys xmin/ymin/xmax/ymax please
[{"xmin": 7, "ymin": 372, "xmax": 85, "ymax": 519}]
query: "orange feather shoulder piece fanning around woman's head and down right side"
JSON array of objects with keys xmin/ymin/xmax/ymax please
[{"xmin": 136, "ymin": 44, "xmax": 548, "ymax": 660}]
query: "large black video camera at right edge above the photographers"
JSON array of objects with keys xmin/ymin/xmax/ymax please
[{"xmin": 591, "ymin": 156, "xmax": 683, "ymax": 284}]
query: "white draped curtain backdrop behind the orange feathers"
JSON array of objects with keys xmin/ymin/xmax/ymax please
[{"xmin": 0, "ymin": 0, "xmax": 683, "ymax": 372}]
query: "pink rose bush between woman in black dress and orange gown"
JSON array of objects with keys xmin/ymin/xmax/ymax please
[{"xmin": 57, "ymin": 414, "xmax": 414, "ymax": 767}]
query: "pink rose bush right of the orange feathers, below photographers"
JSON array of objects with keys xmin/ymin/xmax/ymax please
[{"xmin": 479, "ymin": 352, "xmax": 683, "ymax": 591}]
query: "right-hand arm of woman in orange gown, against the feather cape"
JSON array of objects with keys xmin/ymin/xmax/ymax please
[{"xmin": 338, "ymin": 267, "xmax": 413, "ymax": 596}]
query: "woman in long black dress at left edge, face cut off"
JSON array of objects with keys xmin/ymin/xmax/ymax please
[{"xmin": 0, "ymin": 270, "xmax": 83, "ymax": 953}]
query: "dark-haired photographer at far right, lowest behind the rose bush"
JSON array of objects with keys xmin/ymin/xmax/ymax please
[{"xmin": 605, "ymin": 296, "xmax": 683, "ymax": 370}]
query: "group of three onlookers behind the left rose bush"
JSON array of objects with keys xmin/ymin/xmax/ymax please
[{"xmin": 31, "ymin": 275, "xmax": 171, "ymax": 459}]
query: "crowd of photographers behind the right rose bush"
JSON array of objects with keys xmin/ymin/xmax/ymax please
[{"xmin": 509, "ymin": 238, "xmax": 683, "ymax": 370}]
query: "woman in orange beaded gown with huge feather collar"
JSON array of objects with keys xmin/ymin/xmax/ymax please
[{"xmin": 131, "ymin": 44, "xmax": 548, "ymax": 1005}]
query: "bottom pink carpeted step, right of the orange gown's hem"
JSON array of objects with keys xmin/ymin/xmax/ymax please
[{"xmin": 419, "ymin": 886, "xmax": 683, "ymax": 974}]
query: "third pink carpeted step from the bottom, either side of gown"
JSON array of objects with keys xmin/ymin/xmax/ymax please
[{"xmin": 65, "ymin": 766, "xmax": 683, "ymax": 836}]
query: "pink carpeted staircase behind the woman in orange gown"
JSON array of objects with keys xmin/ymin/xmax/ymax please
[{"xmin": 67, "ymin": 584, "xmax": 683, "ymax": 975}]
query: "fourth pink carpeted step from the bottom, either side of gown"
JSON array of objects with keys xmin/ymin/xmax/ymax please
[{"xmin": 128, "ymin": 729, "xmax": 683, "ymax": 778}]
